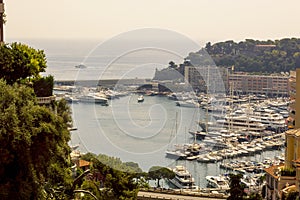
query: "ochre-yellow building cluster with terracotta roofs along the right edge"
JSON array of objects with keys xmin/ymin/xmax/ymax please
[{"xmin": 265, "ymin": 69, "xmax": 300, "ymax": 200}]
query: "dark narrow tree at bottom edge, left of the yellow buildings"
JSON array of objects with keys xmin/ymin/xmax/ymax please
[{"xmin": 227, "ymin": 174, "xmax": 246, "ymax": 200}]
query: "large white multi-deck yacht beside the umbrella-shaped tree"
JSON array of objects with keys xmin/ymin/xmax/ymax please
[{"xmin": 169, "ymin": 165, "xmax": 197, "ymax": 189}]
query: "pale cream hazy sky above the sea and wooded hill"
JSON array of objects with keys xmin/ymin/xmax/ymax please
[{"xmin": 4, "ymin": 0, "xmax": 300, "ymax": 41}]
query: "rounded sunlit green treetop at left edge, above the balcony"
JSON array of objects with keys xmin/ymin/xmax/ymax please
[{"xmin": 0, "ymin": 43, "xmax": 46, "ymax": 84}]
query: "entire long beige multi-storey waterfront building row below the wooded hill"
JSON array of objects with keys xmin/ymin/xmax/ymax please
[{"xmin": 184, "ymin": 66, "xmax": 290, "ymax": 96}]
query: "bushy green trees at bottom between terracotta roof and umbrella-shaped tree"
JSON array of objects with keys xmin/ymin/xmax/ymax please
[{"xmin": 79, "ymin": 153, "xmax": 142, "ymax": 199}]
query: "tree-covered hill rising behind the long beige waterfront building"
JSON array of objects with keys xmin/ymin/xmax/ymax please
[{"xmin": 187, "ymin": 38, "xmax": 300, "ymax": 73}]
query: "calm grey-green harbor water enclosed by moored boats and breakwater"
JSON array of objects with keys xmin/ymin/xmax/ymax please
[{"xmin": 71, "ymin": 94, "xmax": 283, "ymax": 188}]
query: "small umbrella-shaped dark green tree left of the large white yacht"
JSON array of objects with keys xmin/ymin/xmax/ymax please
[{"xmin": 148, "ymin": 166, "xmax": 175, "ymax": 187}]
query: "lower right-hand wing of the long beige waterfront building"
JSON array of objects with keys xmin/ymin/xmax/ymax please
[{"xmin": 228, "ymin": 72, "xmax": 289, "ymax": 96}]
